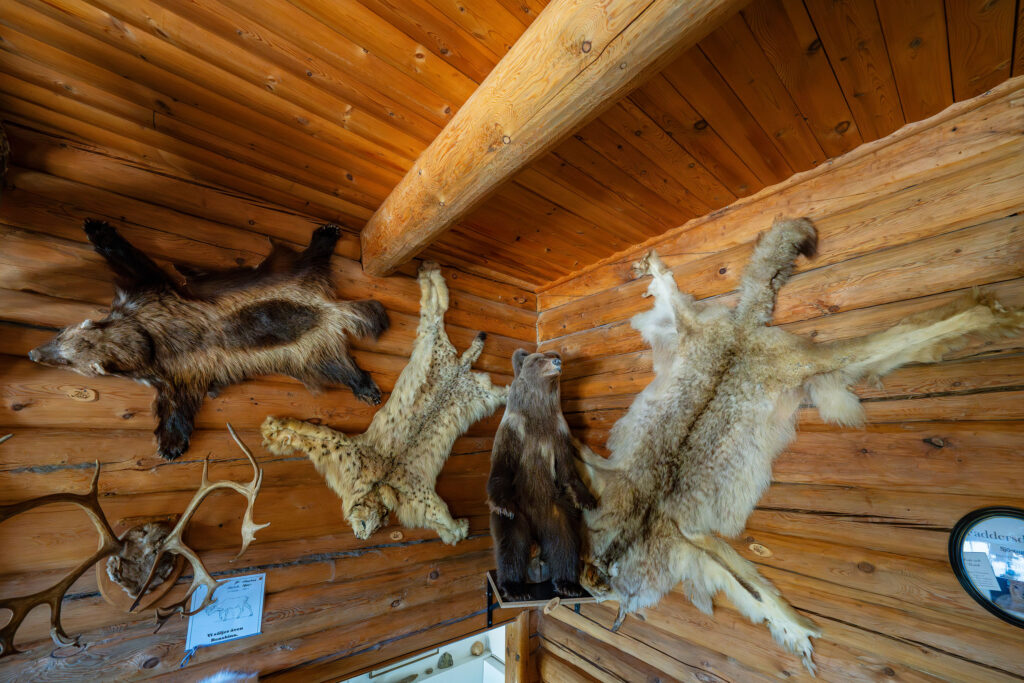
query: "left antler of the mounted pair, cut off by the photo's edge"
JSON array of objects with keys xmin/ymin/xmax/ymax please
[{"xmin": 0, "ymin": 434, "xmax": 122, "ymax": 658}]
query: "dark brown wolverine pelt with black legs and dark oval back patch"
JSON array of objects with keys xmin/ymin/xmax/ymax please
[{"xmin": 29, "ymin": 220, "xmax": 388, "ymax": 460}]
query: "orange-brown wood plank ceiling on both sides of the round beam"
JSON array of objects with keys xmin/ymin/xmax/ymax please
[{"xmin": 0, "ymin": 0, "xmax": 1024, "ymax": 290}]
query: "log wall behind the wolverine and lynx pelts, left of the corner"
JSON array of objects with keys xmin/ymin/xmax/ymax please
[{"xmin": 0, "ymin": 118, "xmax": 537, "ymax": 681}]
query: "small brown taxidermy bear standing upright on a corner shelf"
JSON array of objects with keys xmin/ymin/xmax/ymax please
[{"xmin": 487, "ymin": 349, "xmax": 597, "ymax": 600}]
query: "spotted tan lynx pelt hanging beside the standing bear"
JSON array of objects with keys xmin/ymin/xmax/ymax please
[{"xmin": 262, "ymin": 262, "xmax": 508, "ymax": 544}]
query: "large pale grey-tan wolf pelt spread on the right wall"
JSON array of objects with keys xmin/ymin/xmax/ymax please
[{"xmin": 581, "ymin": 219, "xmax": 1024, "ymax": 673}]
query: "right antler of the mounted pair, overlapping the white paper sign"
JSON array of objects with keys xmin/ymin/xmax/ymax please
[{"xmin": 129, "ymin": 424, "xmax": 270, "ymax": 631}]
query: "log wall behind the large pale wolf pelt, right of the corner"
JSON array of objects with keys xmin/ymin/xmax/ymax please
[{"xmin": 539, "ymin": 78, "xmax": 1024, "ymax": 683}]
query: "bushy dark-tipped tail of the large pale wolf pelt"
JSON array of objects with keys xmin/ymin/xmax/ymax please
[{"xmin": 736, "ymin": 218, "xmax": 818, "ymax": 325}]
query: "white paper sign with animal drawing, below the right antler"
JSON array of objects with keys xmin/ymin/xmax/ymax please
[{"xmin": 185, "ymin": 573, "xmax": 266, "ymax": 652}]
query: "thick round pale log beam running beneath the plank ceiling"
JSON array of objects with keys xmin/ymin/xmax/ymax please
[{"xmin": 361, "ymin": 0, "xmax": 744, "ymax": 275}]
